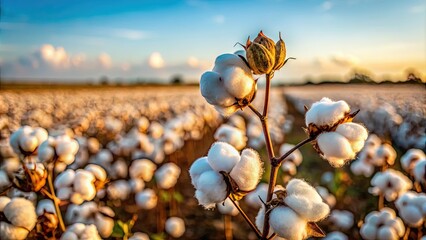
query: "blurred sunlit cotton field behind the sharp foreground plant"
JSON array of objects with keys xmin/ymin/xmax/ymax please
[{"xmin": 0, "ymin": 84, "xmax": 426, "ymax": 239}]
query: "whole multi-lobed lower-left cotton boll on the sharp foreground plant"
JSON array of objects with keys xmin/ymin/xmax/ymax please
[{"xmin": 189, "ymin": 142, "xmax": 263, "ymax": 209}]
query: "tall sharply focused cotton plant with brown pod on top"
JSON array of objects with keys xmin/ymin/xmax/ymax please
[{"xmin": 195, "ymin": 31, "xmax": 368, "ymax": 240}]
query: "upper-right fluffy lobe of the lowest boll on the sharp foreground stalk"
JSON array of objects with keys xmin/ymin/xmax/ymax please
[{"xmin": 284, "ymin": 179, "xmax": 330, "ymax": 222}]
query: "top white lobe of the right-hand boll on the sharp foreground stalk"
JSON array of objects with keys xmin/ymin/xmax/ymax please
[{"xmin": 305, "ymin": 98, "xmax": 350, "ymax": 127}]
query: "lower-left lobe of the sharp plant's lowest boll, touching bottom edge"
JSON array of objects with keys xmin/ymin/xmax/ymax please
[{"xmin": 269, "ymin": 206, "xmax": 308, "ymax": 240}]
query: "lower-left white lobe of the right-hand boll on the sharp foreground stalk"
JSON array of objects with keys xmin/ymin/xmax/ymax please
[{"xmin": 317, "ymin": 132, "xmax": 355, "ymax": 167}]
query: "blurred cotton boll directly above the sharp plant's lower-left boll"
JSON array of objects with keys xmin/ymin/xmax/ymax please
[{"xmin": 214, "ymin": 124, "xmax": 247, "ymax": 150}]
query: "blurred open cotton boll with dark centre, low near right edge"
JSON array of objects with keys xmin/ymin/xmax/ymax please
[{"xmin": 370, "ymin": 169, "xmax": 413, "ymax": 201}]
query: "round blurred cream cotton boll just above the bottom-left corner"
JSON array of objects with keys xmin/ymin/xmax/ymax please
[{"xmin": 3, "ymin": 198, "xmax": 37, "ymax": 231}]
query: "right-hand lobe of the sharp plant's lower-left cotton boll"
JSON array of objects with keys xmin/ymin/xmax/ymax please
[{"xmin": 229, "ymin": 149, "xmax": 263, "ymax": 191}]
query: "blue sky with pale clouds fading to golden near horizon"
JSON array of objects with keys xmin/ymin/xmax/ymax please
[{"xmin": 0, "ymin": 0, "xmax": 426, "ymax": 81}]
